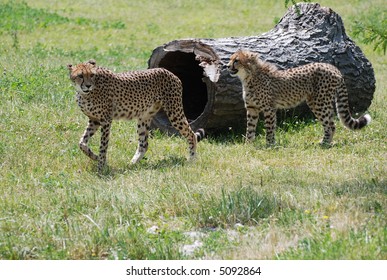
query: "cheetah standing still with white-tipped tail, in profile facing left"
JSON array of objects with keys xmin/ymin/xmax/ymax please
[{"xmin": 227, "ymin": 50, "xmax": 371, "ymax": 146}]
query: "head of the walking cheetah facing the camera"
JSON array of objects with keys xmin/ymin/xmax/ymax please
[{"xmin": 67, "ymin": 59, "xmax": 97, "ymax": 94}]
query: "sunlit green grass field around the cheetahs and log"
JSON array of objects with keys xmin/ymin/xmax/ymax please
[{"xmin": 0, "ymin": 0, "xmax": 387, "ymax": 259}]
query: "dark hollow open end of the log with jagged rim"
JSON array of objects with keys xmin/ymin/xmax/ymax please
[{"xmin": 148, "ymin": 40, "xmax": 219, "ymax": 133}]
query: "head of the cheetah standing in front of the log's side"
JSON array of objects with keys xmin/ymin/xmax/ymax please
[{"xmin": 227, "ymin": 50, "xmax": 257, "ymax": 79}]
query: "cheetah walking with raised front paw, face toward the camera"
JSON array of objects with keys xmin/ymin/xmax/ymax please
[{"xmin": 67, "ymin": 59, "xmax": 204, "ymax": 172}]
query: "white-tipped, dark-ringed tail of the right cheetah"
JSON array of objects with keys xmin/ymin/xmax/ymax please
[{"xmin": 336, "ymin": 83, "xmax": 371, "ymax": 130}]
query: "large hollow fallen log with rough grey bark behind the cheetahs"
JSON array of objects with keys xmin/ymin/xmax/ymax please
[{"xmin": 148, "ymin": 3, "xmax": 375, "ymax": 133}]
